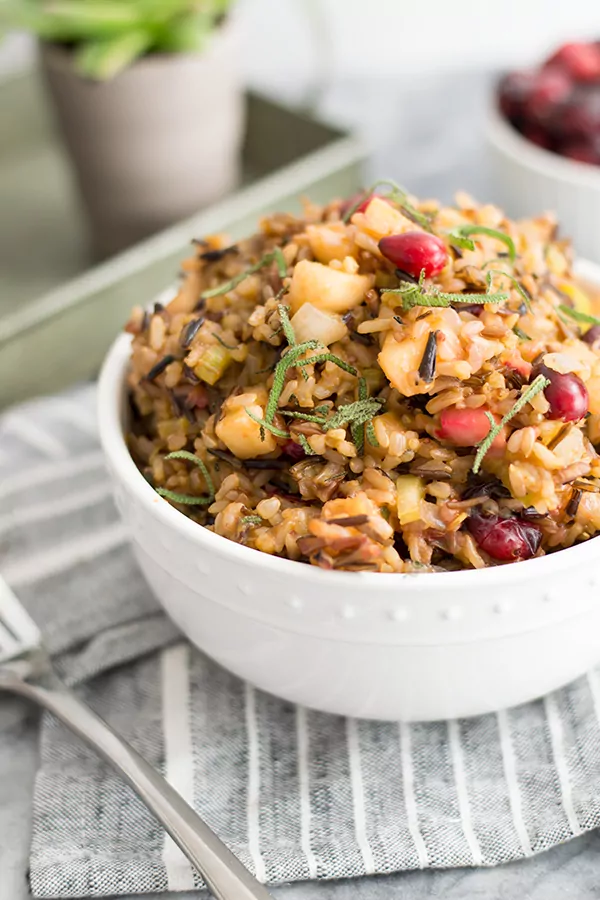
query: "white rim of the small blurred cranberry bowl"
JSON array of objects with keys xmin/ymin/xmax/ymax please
[{"xmin": 486, "ymin": 98, "xmax": 600, "ymax": 190}]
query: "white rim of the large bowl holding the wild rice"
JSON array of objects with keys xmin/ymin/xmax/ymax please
[{"xmin": 97, "ymin": 259, "xmax": 600, "ymax": 603}]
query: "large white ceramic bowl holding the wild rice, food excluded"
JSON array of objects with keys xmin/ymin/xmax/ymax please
[{"xmin": 98, "ymin": 264, "xmax": 600, "ymax": 721}]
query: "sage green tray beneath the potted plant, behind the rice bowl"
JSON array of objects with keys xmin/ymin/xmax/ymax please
[{"xmin": 0, "ymin": 74, "xmax": 366, "ymax": 408}]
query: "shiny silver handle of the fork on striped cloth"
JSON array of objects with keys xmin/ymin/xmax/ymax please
[{"xmin": 9, "ymin": 681, "xmax": 272, "ymax": 900}]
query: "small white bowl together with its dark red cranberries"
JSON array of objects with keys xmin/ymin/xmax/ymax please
[{"xmin": 487, "ymin": 41, "xmax": 600, "ymax": 262}]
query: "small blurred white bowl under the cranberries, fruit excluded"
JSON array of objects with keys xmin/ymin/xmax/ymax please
[{"xmin": 486, "ymin": 105, "xmax": 600, "ymax": 262}]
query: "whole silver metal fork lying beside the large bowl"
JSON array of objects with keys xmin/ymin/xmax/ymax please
[{"xmin": 0, "ymin": 578, "xmax": 272, "ymax": 900}]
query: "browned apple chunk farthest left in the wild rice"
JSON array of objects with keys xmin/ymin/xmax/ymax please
[{"xmin": 215, "ymin": 388, "xmax": 277, "ymax": 459}]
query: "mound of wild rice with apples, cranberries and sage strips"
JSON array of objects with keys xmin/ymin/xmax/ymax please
[{"xmin": 127, "ymin": 182, "xmax": 600, "ymax": 572}]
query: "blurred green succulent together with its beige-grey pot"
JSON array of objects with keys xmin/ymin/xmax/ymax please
[{"xmin": 0, "ymin": 0, "xmax": 243, "ymax": 256}]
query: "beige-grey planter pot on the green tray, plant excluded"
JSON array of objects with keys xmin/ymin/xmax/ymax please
[{"xmin": 41, "ymin": 21, "xmax": 244, "ymax": 257}]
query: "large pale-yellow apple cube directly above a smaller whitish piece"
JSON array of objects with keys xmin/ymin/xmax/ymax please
[{"xmin": 287, "ymin": 259, "xmax": 371, "ymax": 313}]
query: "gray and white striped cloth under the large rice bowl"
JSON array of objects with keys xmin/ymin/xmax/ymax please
[{"xmin": 0, "ymin": 388, "xmax": 600, "ymax": 897}]
